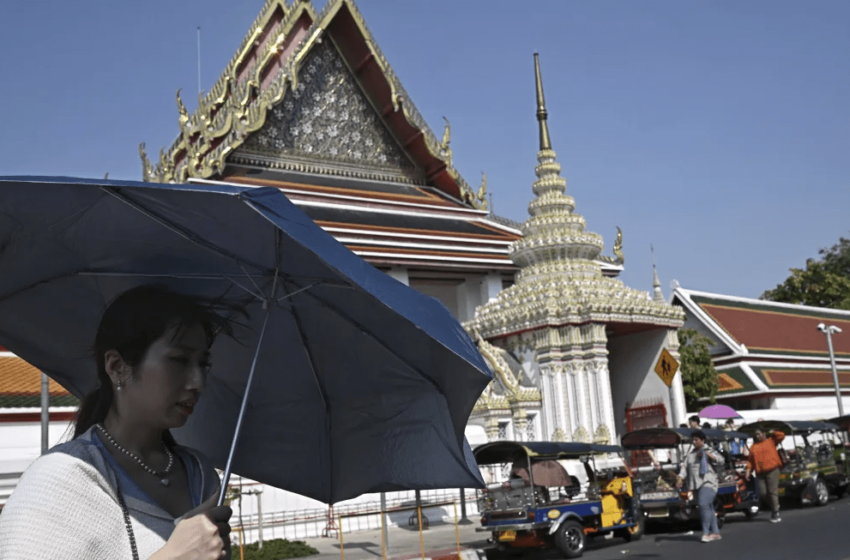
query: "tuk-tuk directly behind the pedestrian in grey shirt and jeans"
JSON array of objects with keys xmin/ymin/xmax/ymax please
[{"xmin": 622, "ymin": 428, "xmax": 759, "ymax": 526}]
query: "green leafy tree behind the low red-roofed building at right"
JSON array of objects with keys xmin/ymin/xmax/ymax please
[{"xmin": 760, "ymin": 237, "xmax": 850, "ymax": 310}]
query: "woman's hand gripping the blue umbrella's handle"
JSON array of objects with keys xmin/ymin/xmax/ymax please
[{"xmin": 151, "ymin": 492, "xmax": 233, "ymax": 560}]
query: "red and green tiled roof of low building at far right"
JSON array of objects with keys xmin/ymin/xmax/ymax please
[{"xmin": 672, "ymin": 287, "xmax": 850, "ymax": 399}]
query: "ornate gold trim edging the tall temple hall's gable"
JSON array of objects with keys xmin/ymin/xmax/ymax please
[{"xmin": 143, "ymin": 0, "xmax": 476, "ymax": 209}]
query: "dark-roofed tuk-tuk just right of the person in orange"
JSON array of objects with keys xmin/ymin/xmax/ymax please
[{"xmin": 741, "ymin": 420, "xmax": 850, "ymax": 506}]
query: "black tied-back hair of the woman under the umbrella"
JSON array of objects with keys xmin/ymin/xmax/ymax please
[{"xmin": 74, "ymin": 285, "xmax": 238, "ymax": 445}]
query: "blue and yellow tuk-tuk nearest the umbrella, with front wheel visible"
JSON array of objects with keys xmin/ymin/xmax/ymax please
[{"xmin": 473, "ymin": 441, "xmax": 644, "ymax": 558}]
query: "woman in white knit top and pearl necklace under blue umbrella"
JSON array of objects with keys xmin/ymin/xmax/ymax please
[{"xmin": 0, "ymin": 286, "xmax": 240, "ymax": 560}]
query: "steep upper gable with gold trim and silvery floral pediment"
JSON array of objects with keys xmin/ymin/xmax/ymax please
[{"xmin": 140, "ymin": 0, "xmax": 486, "ymax": 208}]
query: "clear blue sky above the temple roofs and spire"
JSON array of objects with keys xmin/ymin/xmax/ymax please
[{"xmin": 0, "ymin": 0, "xmax": 850, "ymax": 297}]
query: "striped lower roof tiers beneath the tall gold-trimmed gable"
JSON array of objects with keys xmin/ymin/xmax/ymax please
[{"xmin": 193, "ymin": 173, "xmax": 520, "ymax": 273}]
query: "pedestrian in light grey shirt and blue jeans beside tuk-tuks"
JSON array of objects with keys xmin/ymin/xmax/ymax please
[{"xmin": 676, "ymin": 430, "xmax": 723, "ymax": 542}]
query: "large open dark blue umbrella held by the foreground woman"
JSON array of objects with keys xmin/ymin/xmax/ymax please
[{"xmin": 0, "ymin": 177, "xmax": 492, "ymax": 503}]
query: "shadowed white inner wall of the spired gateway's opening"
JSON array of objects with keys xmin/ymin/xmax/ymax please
[{"xmin": 608, "ymin": 329, "xmax": 681, "ymax": 436}]
